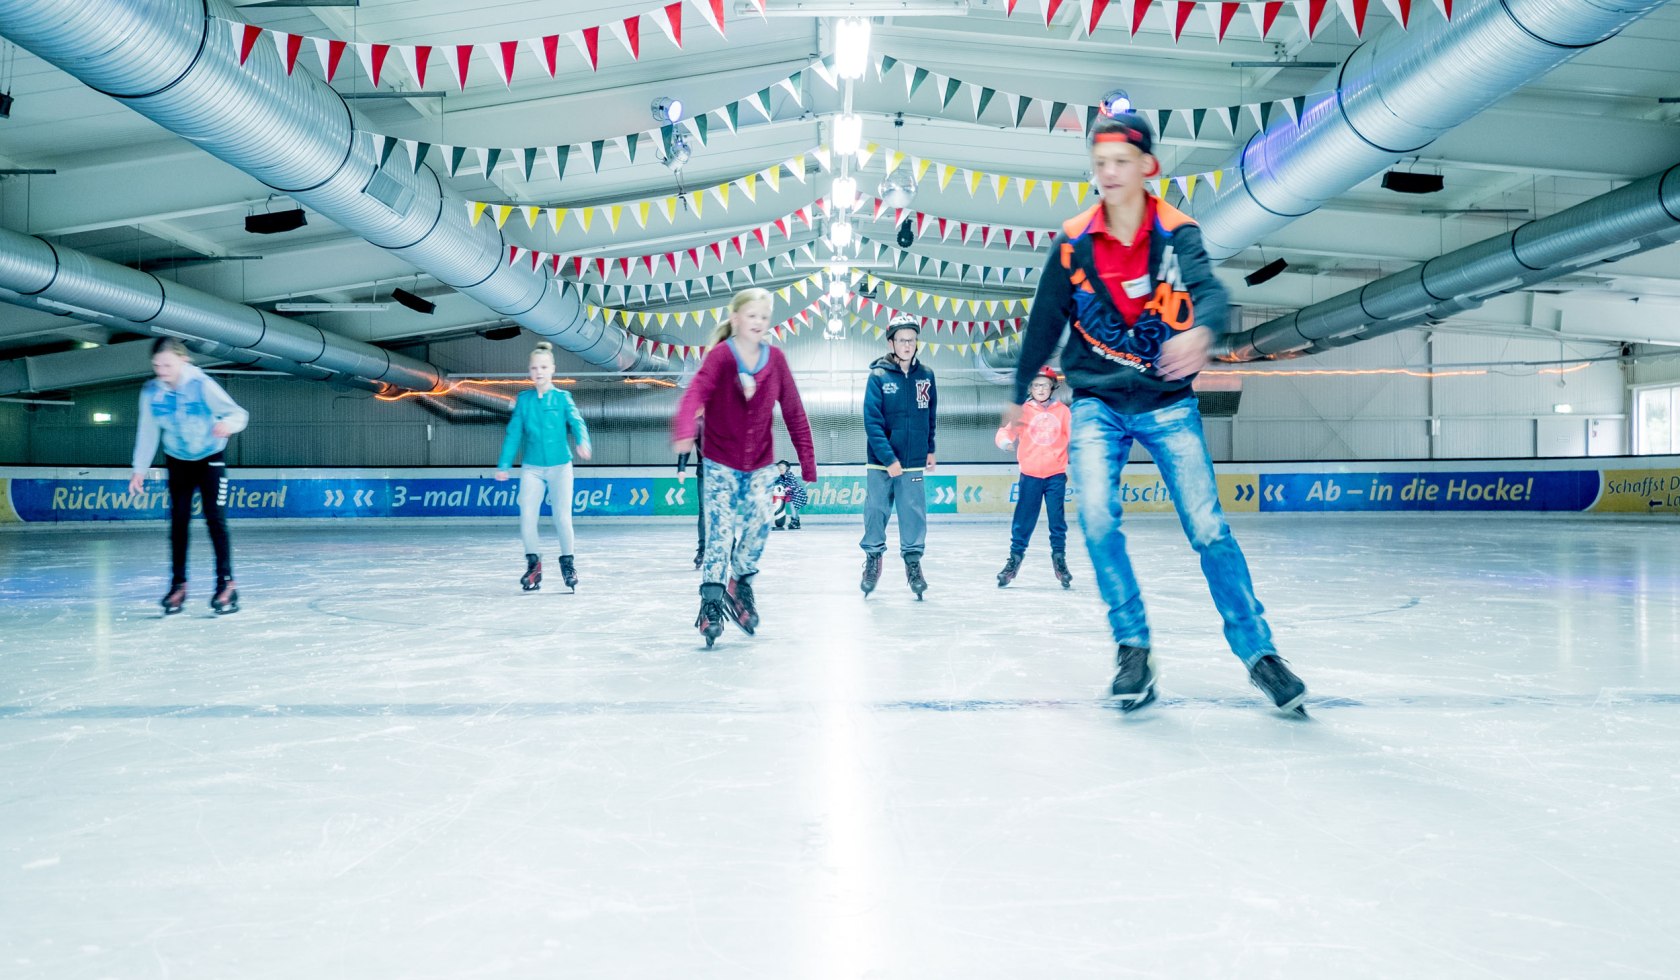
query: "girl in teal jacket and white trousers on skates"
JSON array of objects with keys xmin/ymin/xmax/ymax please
[{"xmin": 496, "ymin": 341, "xmax": 590, "ymax": 592}]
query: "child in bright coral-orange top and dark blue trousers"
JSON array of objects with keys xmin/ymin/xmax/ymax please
[{"xmin": 996, "ymin": 368, "xmax": 1074, "ymax": 588}]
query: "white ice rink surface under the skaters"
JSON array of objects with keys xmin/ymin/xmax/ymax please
[{"xmin": 0, "ymin": 516, "xmax": 1680, "ymax": 980}]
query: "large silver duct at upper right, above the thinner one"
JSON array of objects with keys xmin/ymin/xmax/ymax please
[{"xmin": 1196, "ymin": 0, "xmax": 1665, "ymax": 261}]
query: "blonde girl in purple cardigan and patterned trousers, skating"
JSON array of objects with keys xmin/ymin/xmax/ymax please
[{"xmin": 672, "ymin": 289, "xmax": 816, "ymax": 647}]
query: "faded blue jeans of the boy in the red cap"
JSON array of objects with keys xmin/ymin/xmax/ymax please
[{"xmin": 1068, "ymin": 397, "xmax": 1277, "ymax": 664}]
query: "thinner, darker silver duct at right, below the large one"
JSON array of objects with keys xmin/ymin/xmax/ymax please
[{"xmin": 1228, "ymin": 166, "xmax": 1680, "ymax": 360}]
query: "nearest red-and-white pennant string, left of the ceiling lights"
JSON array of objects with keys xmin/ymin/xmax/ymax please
[{"xmin": 223, "ymin": 0, "xmax": 764, "ymax": 91}]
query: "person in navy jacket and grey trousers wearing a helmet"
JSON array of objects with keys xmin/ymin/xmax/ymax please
[{"xmin": 858, "ymin": 313, "xmax": 939, "ymax": 600}]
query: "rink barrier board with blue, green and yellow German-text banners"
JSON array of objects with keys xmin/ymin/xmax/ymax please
[{"xmin": 0, "ymin": 457, "xmax": 1680, "ymax": 524}]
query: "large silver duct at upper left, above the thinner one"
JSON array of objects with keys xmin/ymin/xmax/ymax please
[{"xmin": 0, "ymin": 0, "xmax": 664, "ymax": 370}]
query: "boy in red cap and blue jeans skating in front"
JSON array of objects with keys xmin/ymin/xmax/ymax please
[{"xmin": 1003, "ymin": 113, "xmax": 1307, "ymax": 714}]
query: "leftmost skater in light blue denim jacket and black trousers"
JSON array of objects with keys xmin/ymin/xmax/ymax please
[{"xmin": 128, "ymin": 336, "xmax": 250, "ymax": 615}]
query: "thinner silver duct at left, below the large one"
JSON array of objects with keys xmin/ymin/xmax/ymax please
[{"xmin": 0, "ymin": 229, "xmax": 442, "ymax": 392}]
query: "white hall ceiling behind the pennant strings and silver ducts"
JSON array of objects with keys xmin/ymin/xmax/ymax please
[{"xmin": 0, "ymin": 0, "xmax": 1680, "ymax": 376}]
